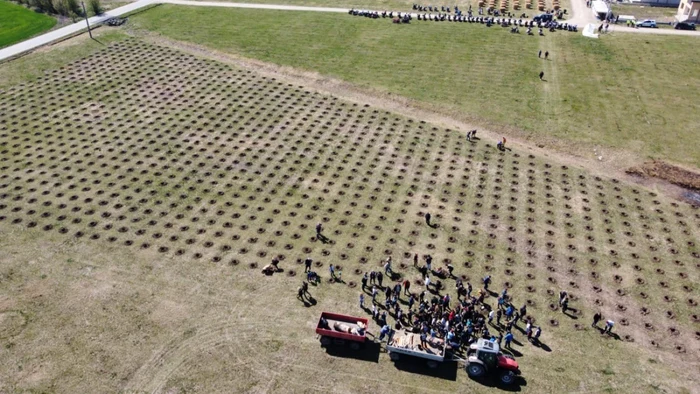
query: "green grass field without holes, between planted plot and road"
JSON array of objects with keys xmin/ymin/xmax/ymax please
[{"xmin": 133, "ymin": 6, "xmax": 700, "ymax": 166}]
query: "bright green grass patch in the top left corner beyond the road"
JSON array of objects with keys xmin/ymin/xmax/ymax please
[{"xmin": 0, "ymin": 0, "xmax": 56, "ymax": 48}]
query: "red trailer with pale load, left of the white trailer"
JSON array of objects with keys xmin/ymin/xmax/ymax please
[{"xmin": 316, "ymin": 312, "xmax": 369, "ymax": 349}]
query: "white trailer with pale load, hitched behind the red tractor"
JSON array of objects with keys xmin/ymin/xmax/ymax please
[{"xmin": 386, "ymin": 330, "xmax": 447, "ymax": 368}]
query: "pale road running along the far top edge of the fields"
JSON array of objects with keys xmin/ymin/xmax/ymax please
[{"xmin": 0, "ymin": 0, "xmax": 700, "ymax": 62}]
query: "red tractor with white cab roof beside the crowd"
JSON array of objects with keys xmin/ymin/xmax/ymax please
[{"xmin": 467, "ymin": 339, "xmax": 520, "ymax": 385}]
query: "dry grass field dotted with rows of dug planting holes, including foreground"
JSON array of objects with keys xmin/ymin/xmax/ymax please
[{"xmin": 0, "ymin": 40, "xmax": 700, "ymax": 393}]
